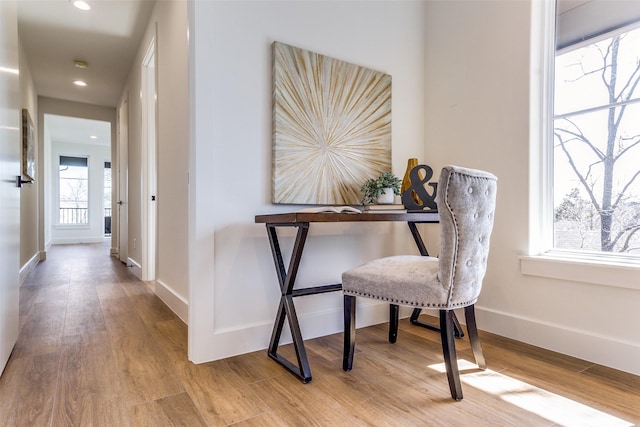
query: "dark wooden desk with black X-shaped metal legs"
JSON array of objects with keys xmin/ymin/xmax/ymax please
[{"xmin": 255, "ymin": 212, "xmax": 440, "ymax": 383}]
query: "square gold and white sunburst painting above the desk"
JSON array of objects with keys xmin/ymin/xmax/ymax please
[{"xmin": 272, "ymin": 42, "xmax": 391, "ymax": 205}]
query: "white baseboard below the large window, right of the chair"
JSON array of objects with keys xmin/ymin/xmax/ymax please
[{"xmin": 476, "ymin": 306, "xmax": 640, "ymax": 375}]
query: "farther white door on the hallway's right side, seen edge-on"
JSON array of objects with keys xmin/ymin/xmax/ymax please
[{"xmin": 116, "ymin": 99, "xmax": 129, "ymax": 264}]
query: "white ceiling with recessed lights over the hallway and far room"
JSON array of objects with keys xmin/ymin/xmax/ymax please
[{"xmin": 19, "ymin": 0, "xmax": 155, "ymax": 142}]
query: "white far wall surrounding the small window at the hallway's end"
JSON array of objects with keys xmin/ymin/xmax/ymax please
[{"xmin": 45, "ymin": 140, "xmax": 111, "ymax": 244}]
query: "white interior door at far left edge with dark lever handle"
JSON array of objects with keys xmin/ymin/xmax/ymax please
[{"xmin": 0, "ymin": 0, "xmax": 21, "ymax": 372}]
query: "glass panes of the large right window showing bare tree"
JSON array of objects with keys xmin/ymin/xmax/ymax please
[{"xmin": 552, "ymin": 6, "xmax": 640, "ymax": 256}]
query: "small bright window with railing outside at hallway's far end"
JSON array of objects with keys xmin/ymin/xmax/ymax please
[{"xmin": 58, "ymin": 156, "xmax": 89, "ymax": 224}]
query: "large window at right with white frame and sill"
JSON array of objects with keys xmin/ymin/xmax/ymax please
[{"xmin": 520, "ymin": 0, "xmax": 640, "ymax": 290}]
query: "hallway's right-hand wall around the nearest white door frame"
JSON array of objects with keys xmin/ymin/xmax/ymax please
[{"xmin": 121, "ymin": 1, "xmax": 189, "ymax": 321}]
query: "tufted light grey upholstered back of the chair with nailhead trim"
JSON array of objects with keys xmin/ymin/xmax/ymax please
[{"xmin": 436, "ymin": 166, "xmax": 497, "ymax": 308}]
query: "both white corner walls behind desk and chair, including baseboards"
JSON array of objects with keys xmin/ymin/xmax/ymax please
[{"xmin": 189, "ymin": 0, "xmax": 640, "ymax": 373}]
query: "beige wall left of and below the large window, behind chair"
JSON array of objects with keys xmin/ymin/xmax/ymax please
[{"xmin": 425, "ymin": 1, "xmax": 640, "ymax": 374}]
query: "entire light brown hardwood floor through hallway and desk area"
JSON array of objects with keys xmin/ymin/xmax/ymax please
[{"xmin": 0, "ymin": 244, "xmax": 640, "ymax": 426}]
